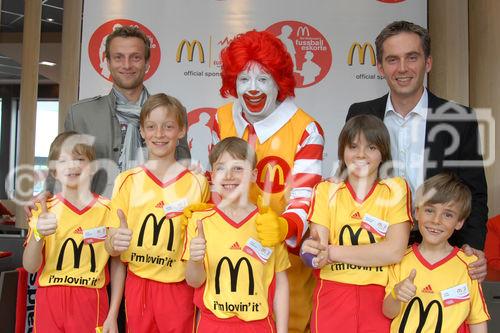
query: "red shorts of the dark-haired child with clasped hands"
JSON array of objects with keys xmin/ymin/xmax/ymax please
[{"xmin": 311, "ymin": 279, "xmax": 391, "ymax": 333}]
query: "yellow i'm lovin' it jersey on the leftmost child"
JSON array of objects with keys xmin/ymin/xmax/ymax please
[{"xmin": 29, "ymin": 194, "xmax": 111, "ymax": 288}]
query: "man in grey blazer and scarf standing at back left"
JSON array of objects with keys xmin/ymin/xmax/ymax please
[{"xmin": 64, "ymin": 26, "xmax": 191, "ymax": 196}]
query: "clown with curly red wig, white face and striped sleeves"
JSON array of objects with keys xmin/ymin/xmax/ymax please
[{"xmin": 212, "ymin": 31, "xmax": 324, "ymax": 332}]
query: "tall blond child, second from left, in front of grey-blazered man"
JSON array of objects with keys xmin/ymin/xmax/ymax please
[{"xmin": 106, "ymin": 94, "xmax": 209, "ymax": 333}]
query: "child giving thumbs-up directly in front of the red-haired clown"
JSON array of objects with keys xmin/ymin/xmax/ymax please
[{"xmin": 183, "ymin": 137, "xmax": 290, "ymax": 333}]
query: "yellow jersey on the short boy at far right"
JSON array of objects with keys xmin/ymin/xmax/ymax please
[{"xmin": 386, "ymin": 244, "xmax": 490, "ymax": 333}]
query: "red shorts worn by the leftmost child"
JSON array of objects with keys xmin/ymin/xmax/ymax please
[{"xmin": 35, "ymin": 286, "xmax": 109, "ymax": 333}]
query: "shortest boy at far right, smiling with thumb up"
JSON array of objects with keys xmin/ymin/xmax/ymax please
[{"xmin": 383, "ymin": 173, "xmax": 490, "ymax": 333}]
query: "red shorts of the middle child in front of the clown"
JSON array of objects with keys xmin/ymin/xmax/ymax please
[{"xmin": 196, "ymin": 310, "xmax": 276, "ymax": 333}]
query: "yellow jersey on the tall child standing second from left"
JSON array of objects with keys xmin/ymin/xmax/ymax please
[{"xmin": 111, "ymin": 166, "xmax": 210, "ymax": 282}]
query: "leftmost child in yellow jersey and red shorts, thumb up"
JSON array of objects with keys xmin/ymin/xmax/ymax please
[{"xmin": 23, "ymin": 132, "xmax": 110, "ymax": 333}]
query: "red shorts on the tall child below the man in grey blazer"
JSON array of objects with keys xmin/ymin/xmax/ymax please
[{"xmin": 125, "ymin": 271, "xmax": 195, "ymax": 333}]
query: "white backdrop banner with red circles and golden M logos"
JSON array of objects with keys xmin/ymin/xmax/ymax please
[{"xmin": 80, "ymin": 0, "xmax": 427, "ymax": 176}]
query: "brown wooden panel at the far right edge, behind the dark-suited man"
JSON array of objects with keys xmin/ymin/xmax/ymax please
[{"xmin": 469, "ymin": 0, "xmax": 500, "ymax": 217}]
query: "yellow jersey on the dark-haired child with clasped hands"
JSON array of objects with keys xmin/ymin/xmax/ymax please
[{"xmin": 309, "ymin": 177, "xmax": 411, "ymax": 286}]
